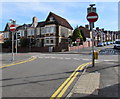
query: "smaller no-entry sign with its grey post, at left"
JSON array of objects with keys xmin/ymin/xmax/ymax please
[{"xmin": 10, "ymin": 20, "xmax": 16, "ymax": 61}]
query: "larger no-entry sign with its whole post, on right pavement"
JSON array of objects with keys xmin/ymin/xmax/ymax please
[{"xmin": 87, "ymin": 4, "xmax": 98, "ymax": 67}]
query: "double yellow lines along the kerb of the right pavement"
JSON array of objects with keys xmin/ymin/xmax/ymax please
[{"xmin": 50, "ymin": 62, "xmax": 91, "ymax": 99}]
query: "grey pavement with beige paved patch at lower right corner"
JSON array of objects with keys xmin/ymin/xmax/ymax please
[{"xmin": 67, "ymin": 58, "xmax": 120, "ymax": 99}]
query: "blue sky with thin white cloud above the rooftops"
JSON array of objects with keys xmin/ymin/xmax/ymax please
[{"xmin": 0, "ymin": 1, "xmax": 118, "ymax": 31}]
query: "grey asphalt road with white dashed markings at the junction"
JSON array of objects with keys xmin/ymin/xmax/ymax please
[{"xmin": 1, "ymin": 46, "xmax": 118, "ymax": 97}]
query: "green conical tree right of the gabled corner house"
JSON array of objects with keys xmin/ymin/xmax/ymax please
[{"xmin": 72, "ymin": 26, "xmax": 83, "ymax": 42}]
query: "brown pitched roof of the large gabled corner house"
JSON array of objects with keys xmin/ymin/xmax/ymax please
[{"xmin": 46, "ymin": 12, "xmax": 73, "ymax": 29}]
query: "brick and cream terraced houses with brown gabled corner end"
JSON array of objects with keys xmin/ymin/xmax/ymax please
[{"xmin": 4, "ymin": 12, "xmax": 73, "ymax": 51}]
